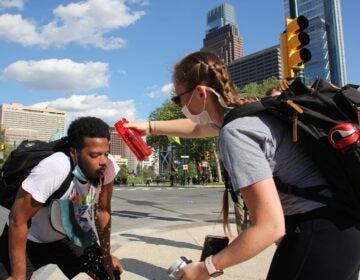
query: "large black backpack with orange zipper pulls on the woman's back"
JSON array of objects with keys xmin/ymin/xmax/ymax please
[{"xmin": 223, "ymin": 79, "xmax": 360, "ymax": 224}]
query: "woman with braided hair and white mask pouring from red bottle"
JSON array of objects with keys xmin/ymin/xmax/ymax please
[{"xmin": 124, "ymin": 52, "xmax": 360, "ymax": 280}]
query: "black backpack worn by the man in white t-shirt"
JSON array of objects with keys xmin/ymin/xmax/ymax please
[{"xmin": 0, "ymin": 137, "xmax": 73, "ymax": 209}]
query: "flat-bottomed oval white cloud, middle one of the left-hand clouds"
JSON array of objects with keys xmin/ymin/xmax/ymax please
[{"xmin": 2, "ymin": 59, "xmax": 108, "ymax": 92}]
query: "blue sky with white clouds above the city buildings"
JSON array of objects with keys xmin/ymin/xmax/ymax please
[{"xmin": 0, "ymin": 0, "xmax": 360, "ymax": 125}]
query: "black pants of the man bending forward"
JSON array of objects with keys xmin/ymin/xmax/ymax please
[{"xmin": 0, "ymin": 226, "xmax": 110, "ymax": 280}]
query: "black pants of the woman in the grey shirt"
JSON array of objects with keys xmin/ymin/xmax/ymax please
[{"xmin": 267, "ymin": 209, "xmax": 360, "ymax": 280}]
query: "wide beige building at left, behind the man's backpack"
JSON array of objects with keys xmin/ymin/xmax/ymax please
[{"xmin": 0, "ymin": 103, "xmax": 66, "ymax": 147}]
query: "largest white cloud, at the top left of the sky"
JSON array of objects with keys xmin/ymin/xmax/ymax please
[{"xmin": 0, "ymin": 0, "xmax": 145, "ymax": 50}]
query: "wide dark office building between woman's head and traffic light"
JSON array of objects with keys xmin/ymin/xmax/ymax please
[{"xmin": 228, "ymin": 45, "xmax": 282, "ymax": 88}]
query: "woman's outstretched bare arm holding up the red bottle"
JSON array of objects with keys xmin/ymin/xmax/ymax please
[{"xmin": 124, "ymin": 119, "xmax": 219, "ymax": 138}]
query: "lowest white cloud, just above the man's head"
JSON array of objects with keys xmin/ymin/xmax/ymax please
[{"xmin": 32, "ymin": 94, "xmax": 136, "ymax": 126}]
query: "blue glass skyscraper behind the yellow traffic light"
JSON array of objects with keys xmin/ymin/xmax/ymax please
[{"xmin": 284, "ymin": 0, "xmax": 347, "ymax": 86}]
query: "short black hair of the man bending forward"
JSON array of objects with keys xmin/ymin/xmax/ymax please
[{"xmin": 67, "ymin": 117, "xmax": 110, "ymax": 150}]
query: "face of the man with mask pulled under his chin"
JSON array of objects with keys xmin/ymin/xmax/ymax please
[{"xmin": 77, "ymin": 137, "xmax": 109, "ymax": 180}]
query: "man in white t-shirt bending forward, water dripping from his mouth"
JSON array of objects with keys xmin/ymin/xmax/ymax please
[{"xmin": 0, "ymin": 117, "xmax": 122, "ymax": 279}]
